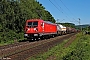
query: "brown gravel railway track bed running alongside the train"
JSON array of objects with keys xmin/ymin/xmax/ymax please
[{"xmin": 0, "ymin": 33, "xmax": 75, "ymax": 60}]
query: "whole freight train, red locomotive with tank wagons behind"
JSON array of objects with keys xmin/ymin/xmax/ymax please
[{"xmin": 24, "ymin": 19, "xmax": 76, "ymax": 39}]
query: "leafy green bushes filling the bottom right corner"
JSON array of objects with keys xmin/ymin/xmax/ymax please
[{"xmin": 63, "ymin": 35, "xmax": 90, "ymax": 60}]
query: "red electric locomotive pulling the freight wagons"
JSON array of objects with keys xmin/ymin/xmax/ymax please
[{"xmin": 24, "ymin": 19, "xmax": 57, "ymax": 39}]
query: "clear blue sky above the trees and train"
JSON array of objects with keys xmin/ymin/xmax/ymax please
[{"xmin": 37, "ymin": 0, "xmax": 90, "ymax": 25}]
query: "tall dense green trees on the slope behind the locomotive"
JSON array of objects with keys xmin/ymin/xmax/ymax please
[{"xmin": 0, "ymin": 0, "xmax": 55, "ymax": 42}]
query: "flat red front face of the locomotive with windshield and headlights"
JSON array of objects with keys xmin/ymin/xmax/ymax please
[{"xmin": 24, "ymin": 21, "xmax": 38, "ymax": 37}]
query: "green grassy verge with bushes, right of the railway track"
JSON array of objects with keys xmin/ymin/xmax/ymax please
[{"xmin": 29, "ymin": 34, "xmax": 90, "ymax": 60}]
